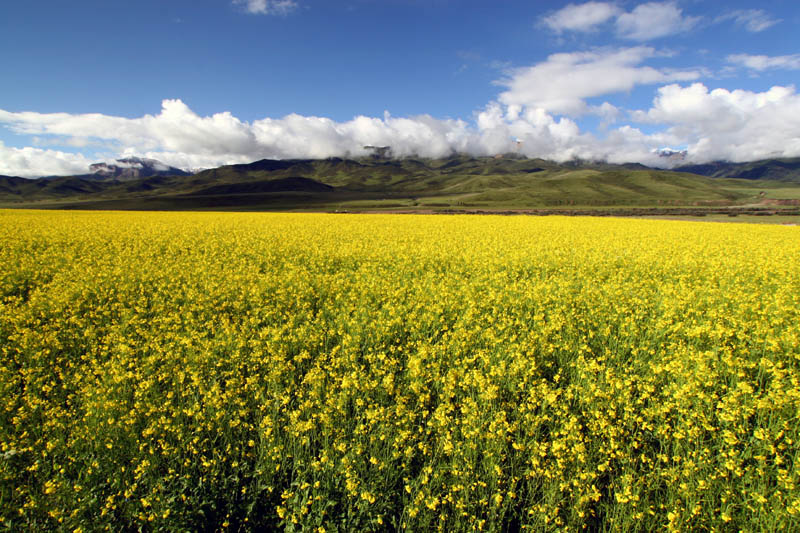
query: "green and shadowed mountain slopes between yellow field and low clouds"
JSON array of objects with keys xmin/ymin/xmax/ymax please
[{"xmin": 0, "ymin": 155, "xmax": 800, "ymax": 210}]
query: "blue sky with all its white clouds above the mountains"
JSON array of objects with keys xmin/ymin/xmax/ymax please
[{"xmin": 0, "ymin": 0, "xmax": 800, "ymax": 177}]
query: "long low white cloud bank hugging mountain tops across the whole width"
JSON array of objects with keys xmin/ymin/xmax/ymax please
[{"xmin": 0, "ymin": 83, "xmax": 800, "ymax": 177}]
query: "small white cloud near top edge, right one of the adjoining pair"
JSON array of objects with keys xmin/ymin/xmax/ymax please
[{"xmin": 617, "ymin": 2, "xmax": 700, "ymax": 41}]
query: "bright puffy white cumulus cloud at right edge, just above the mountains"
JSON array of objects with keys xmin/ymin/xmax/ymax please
[{"xmin": 634, "ymin": 83, "xmax": 800, "ymax": 161}]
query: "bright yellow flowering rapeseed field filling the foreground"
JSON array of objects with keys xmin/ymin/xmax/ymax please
[{"xmin": 0, "ymin": 211, "xmax": 800, "ymax": 532}]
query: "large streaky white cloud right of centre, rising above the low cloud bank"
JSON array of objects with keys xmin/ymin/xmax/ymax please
[{"xmin": 497, "ymin": 46, "xmax": 700, "ymax": 116}]
